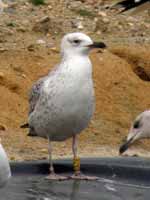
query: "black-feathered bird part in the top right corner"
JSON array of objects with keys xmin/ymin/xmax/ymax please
[{"xmin": 112, "ymin": 0, "xmax": 150, "ymax": 14}]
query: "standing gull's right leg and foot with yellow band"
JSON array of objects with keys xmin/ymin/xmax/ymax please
[{"xmin": 71, "ymin": 135, "xmax": 98, "ymax": 180}]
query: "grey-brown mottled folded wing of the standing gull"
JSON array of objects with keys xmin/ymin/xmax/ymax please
[{"xmin": 29, "ymin": 77, "xmax": 46, "ymax": 114}]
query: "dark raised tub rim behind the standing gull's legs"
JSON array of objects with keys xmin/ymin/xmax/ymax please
[{"xmin": 10, "ymin": 157, "xmax": 150, "ymax": 181}]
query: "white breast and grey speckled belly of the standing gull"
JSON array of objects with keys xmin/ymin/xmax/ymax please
[{"xmin": 29, "ymin": 56, "xmax": 94, "ymax": 141}]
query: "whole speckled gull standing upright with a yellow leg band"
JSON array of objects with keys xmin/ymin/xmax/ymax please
[{"xmin": 21, "ymin": 33, "xmax": 106, "ymax": 180}]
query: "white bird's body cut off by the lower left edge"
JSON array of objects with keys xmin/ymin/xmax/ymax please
[{"xmin": 0, "ymin": 141, "xmax": 11, "ymax": 187}]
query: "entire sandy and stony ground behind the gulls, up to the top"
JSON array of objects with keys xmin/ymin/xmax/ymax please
[{"xmin": 0, "ymin": 0, "xmax": 150, "ymax": 160}]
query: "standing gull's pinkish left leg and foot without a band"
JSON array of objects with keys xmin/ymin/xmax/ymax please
[{"xmin": 46, "ymin": 137, "xmax": 68, "ymax": 181}]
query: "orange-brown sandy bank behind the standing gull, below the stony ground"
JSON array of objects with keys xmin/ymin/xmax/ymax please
[{"xmin": 0, "ymin": 46, "xmax": 150, "ymax": 160}]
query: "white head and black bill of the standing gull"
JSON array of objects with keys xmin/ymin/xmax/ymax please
[{"xmin": 61, "ymin": 32, "xmax": 106, "ymax": 56}]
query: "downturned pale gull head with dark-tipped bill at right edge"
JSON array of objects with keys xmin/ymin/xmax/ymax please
[{"xmin": 119, "ymin": 110, "xmax": 150, "ymax": 154}]
